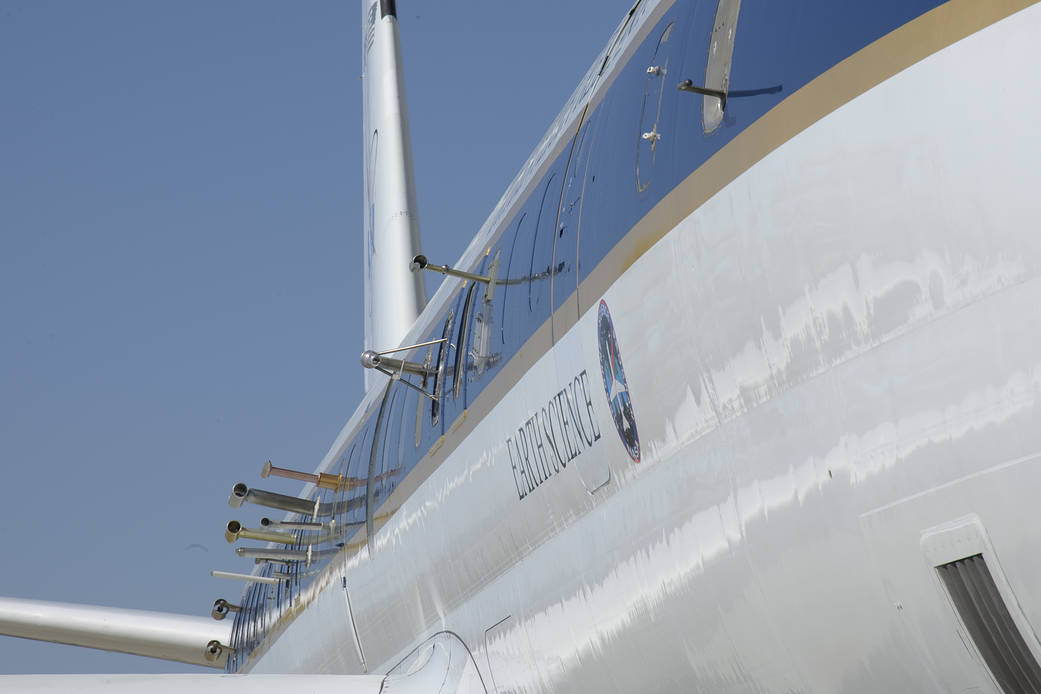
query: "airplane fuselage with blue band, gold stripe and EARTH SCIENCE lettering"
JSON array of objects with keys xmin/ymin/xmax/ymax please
[{"xmin": 229, "ymin": 0, "xmax": 1041, "ymax": 692}]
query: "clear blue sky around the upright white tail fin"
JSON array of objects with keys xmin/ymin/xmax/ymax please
[{"xmin": 0, "ymin": 0, "xmax": 631, "ymax": 673}]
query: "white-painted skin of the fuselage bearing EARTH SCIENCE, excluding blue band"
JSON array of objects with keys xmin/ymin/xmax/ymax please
[{"xmin": 234, "ymin": 1, "xmax": 1041, "ymax": 693}]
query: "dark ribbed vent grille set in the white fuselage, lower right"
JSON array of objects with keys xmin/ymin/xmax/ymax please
[{"xmin": 936, "ymin": 555, "xmax": 1041, "ymax": 694}]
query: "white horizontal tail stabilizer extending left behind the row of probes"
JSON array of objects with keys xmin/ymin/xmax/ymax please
[{"xmin": 0, "ymin": 597, "xmax": 231, "ymax": 668}]
